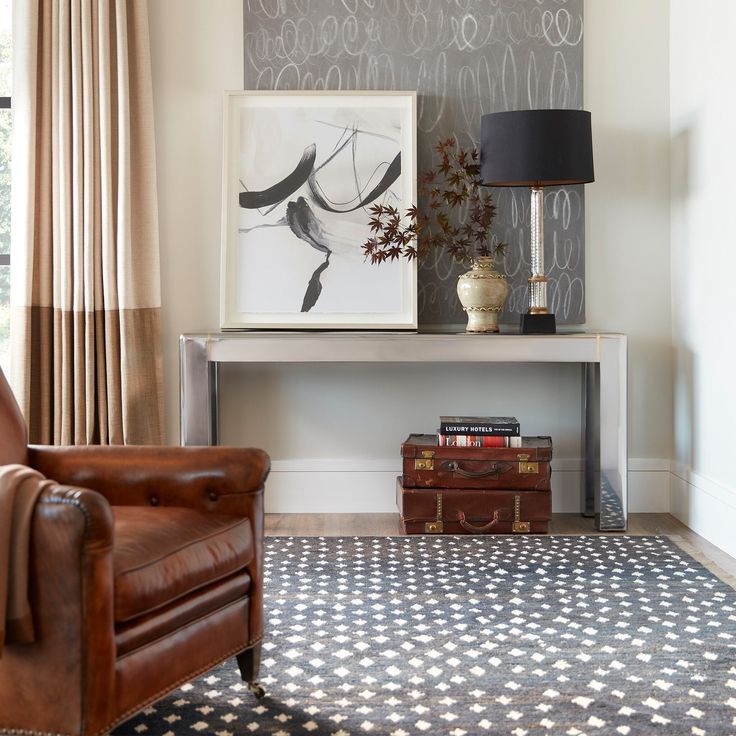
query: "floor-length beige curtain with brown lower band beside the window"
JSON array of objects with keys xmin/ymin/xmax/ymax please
[{"xmin": 11, "ymin": 0, "xmax": 163, "ymax": 444}]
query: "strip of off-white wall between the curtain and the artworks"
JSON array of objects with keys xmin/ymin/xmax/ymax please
[{"xmin": 148, "ymin": 0, "xmax": 243, "ymax": 436}]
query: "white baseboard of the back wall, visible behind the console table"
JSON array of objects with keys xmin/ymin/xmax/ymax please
[{"xmin": 266, "ymin": 458, "xmax": 670, "ymax": 514}]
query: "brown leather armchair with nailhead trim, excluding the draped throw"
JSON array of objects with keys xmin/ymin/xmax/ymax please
[{"xmin": 0, "ymin": 371, "xmax": 269, "ymax": 736}]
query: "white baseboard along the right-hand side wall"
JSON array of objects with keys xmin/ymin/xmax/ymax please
[{"xmin": 670, "ymin": 463, "xmax": 736, "ymax": 557}]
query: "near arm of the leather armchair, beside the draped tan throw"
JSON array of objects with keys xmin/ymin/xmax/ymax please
[{"xmin": 0, "ymin": 486, "xmax": 115, "ymax": 734}]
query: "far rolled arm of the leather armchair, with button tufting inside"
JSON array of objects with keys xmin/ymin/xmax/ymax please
[{"xmin": 28, "ymin": 446, "xmax": 270, "ymax": 514}]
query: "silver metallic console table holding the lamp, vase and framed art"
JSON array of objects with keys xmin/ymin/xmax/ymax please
[{"xmin": 180, "ymin": 332, "xmax": 627, "ymax": 531}]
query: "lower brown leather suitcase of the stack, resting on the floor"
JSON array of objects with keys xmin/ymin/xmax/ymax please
[{"xmin": 396, "ymin": 476, "xmax": 552, "ymax": 534}]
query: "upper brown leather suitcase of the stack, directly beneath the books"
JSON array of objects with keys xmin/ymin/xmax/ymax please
[{"xmin": 401, "ymin": 434, "xmax": 552, "ymax": 491}]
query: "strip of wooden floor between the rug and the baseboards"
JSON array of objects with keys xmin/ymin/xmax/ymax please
[{"xmin": 266, "ymin": 514, "xmax": 736, "ymax": 588}]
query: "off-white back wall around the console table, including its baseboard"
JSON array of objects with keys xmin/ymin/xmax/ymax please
[{"xmin": 149, "ymin": 0, "xmax": 672, "ymax": 511}]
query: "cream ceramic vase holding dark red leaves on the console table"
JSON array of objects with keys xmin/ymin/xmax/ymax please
[{"xmin": 457, "ymin": 256, "xmax": 509, "ymax": 332}]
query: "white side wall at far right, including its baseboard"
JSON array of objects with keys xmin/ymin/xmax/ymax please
[{"xmin": 670, "ymin": 0, "xmax": 736, "ymax": 556}]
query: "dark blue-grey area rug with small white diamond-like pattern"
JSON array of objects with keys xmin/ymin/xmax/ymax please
[{"xmin": 114, "ymin": 536, "xmax": 736, "ymax": 736}]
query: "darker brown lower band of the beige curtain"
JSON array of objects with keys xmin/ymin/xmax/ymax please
[{"xmin": 11, "ymin": 307, "xmax": 164, "ymax": 445}]
